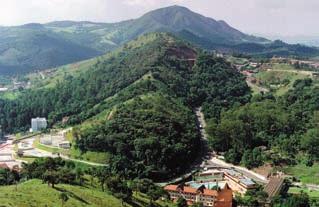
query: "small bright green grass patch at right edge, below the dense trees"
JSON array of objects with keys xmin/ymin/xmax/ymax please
[{"xmin": 283, "ymin": 163, "xmax": 319, "ymax": 185}]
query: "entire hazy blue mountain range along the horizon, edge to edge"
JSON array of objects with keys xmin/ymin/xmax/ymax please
[{"xmin": 0, "ymin": 6, "xmax": 319, "ymax": 74}]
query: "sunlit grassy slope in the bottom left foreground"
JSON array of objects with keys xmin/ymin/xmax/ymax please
[{"xmin": 0, "ymin": 180, "xmax": 174, "ymax": 207}]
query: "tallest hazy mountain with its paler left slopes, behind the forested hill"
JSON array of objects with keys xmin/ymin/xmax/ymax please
[{"xmin": 44, "ymin": 6, "xmax": 270, "ymax": 52}]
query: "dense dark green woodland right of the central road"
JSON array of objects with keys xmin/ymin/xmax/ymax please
[{"xmin": 207, "ymin": 79, "xmax": 319, "ymax": 168}]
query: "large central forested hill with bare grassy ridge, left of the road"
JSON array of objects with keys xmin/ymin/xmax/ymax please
[{"xmin": 0, "ymin": 33, "xmax": 250, "ymax": 179}]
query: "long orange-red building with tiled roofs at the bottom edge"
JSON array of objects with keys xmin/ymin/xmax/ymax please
[{"xmin": 164, "ymin": 184, "xmax": 233, "ymax": 207}]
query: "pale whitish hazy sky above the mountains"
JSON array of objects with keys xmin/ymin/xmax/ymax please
[{"xmin": 0, "ymin": 0, "xmax": 319, "ymax": 37}]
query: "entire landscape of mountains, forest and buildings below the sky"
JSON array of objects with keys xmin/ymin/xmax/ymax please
[{"xmin": 0, "ymin": 3, "xmax": 319, "ymax": 207}]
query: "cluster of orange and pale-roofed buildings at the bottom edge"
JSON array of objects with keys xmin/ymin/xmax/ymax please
[{"xmin": 164, "ymin": 169, "xmax": 257, "ymax": 207}]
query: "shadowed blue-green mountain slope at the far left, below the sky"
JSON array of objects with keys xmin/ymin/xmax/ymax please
[{"xmin": 0, "ymin": 24, "xmax": 102, "ymax": 74}]
